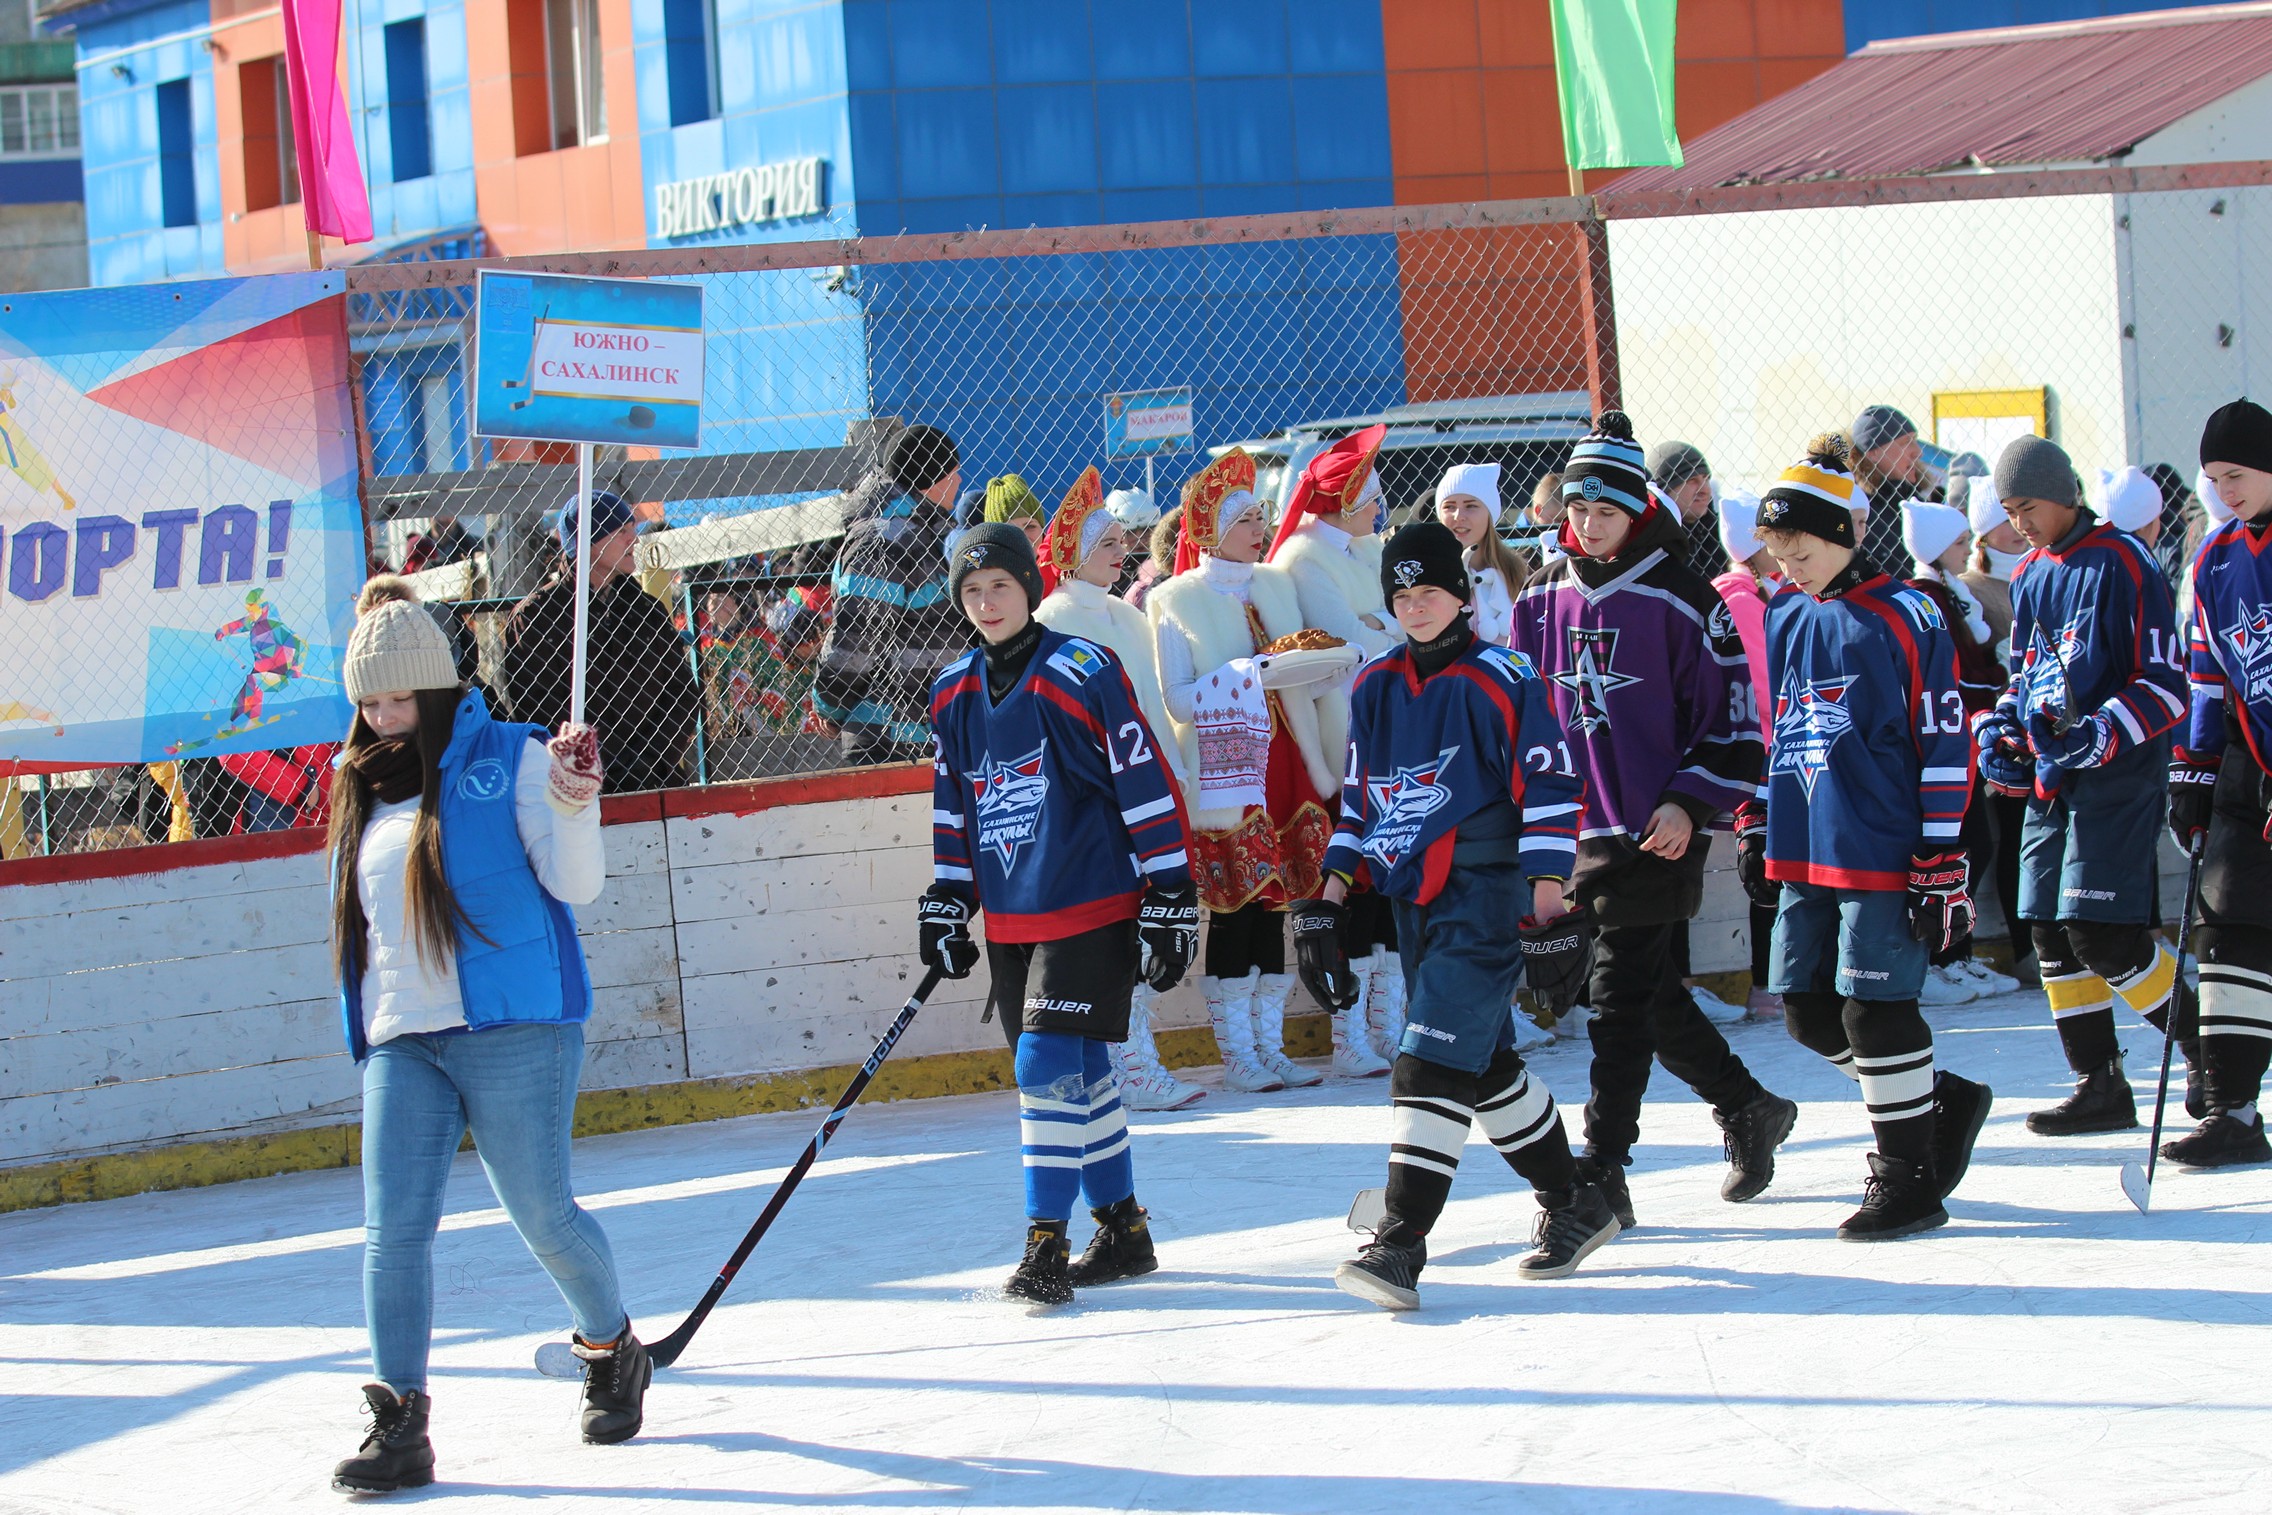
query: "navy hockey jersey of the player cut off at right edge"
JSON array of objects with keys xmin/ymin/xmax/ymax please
[{"xmin": 2181, "ymin": 520, "xmax": 2272, "ymax": 770}]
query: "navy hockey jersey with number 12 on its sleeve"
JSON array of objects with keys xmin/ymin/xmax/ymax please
[{"xmin": 932, "ymin": 629, "xmax": 1191, "ymax": 943}]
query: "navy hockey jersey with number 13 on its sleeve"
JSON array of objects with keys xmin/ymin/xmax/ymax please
[{"xmin": 1761, "ymin": 572, "xmax": 1972, "ymax": 890}]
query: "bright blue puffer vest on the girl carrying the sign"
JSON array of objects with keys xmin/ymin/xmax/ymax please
[{"xmin": 334, "ymin": 690, "xmax": 591, "ymax": 1063}]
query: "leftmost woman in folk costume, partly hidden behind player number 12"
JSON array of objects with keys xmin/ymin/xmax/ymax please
[{"xmin": 1034, "ymin": 468, "xmax": 1206, "ymax": 1111}]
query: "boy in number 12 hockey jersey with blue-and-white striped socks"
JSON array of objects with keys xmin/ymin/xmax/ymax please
[{"xmin": 918, "ymin": 522, "xmax": 1200, "ymax": 1304}]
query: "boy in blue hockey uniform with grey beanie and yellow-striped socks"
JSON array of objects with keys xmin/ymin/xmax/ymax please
[{"xmin": 1977, "ymin": 436, "xmax": 2192, "ymax": 1136}]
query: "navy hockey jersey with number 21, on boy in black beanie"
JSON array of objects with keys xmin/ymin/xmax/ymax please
[{"xmin": 1325, "ymin": 641, "xmax": 1586, "ymax": 904}]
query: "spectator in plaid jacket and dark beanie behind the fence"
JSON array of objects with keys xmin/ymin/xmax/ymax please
[{"xmin": 813, "ymin": 425, "xmax": 970, "ymax": 763}]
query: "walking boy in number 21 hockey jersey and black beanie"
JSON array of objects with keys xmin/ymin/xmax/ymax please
[{"xmin": 1293, "ymin": 520, "xmax": 1618, "ymax": 1311}]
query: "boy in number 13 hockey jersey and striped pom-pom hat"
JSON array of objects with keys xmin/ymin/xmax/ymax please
[{"xmin": 1736, "ymin": 438, "xmax": 1988, "ymax": 1242}]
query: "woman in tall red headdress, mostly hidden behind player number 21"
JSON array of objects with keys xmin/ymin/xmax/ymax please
[{"xmin": 1268, "ymin": 427, "xmax": 1404, "ymax": 1079}]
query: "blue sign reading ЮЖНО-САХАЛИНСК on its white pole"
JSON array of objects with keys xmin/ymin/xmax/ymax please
[{"xmin": 473, "ymin": 268, "xmax": 702, "ymax": 725}]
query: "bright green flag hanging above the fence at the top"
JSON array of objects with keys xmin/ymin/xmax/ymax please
[{"xmin": 1550, "ymin": 0, "xmax": 1681, "ymax": 168}]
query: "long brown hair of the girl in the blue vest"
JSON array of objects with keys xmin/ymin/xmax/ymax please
[{"xmin": 329, "ymin": 688, "xmax": 486, "ymax": 984}]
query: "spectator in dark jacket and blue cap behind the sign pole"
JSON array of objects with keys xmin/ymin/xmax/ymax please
[{"xmin": 500, "ymin": 488, "xmax": 702, "ymax": 795}]
